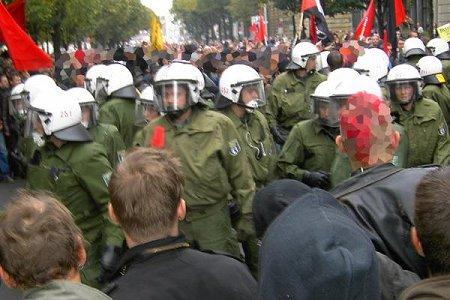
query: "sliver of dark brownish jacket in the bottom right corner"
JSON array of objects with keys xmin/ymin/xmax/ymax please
[{"xmin": 399, "ymin": 275, "xmax": 450, "ymax": 300}]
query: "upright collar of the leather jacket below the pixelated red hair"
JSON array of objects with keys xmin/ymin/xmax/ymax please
[{"xmin": 330, "ymin": 163, "xmax": 403, "ymax": 198}]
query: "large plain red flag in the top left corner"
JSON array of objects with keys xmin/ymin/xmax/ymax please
[{"xmin": 0, "ymin": 2, "xmax": 53, "ymax": 71}]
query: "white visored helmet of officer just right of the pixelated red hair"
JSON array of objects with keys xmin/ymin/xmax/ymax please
[{"xmin": 386, "ymin": 64, "xmax": 422, "ymax": 105}]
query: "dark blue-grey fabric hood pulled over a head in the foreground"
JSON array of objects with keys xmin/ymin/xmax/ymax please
[{"xmin": 259, "ymin": 189, "xmax": 380, "ymax": 299}]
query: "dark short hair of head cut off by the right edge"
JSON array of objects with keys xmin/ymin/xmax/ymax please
[{"xmin": 414, "ymin": 167, "xmax": 450, "ymax": 276}]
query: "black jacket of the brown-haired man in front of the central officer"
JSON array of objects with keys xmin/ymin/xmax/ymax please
[{"xmin": 105, "ymin": 236, "xmax": 257, "ymax": 300}]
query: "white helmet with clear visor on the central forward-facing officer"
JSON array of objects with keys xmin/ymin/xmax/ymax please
[{"xmin": 153, "ymin": 61, "xmax": 205, "ymax": 116}]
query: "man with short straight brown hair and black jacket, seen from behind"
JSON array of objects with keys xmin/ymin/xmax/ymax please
[{"xmin": 107, "ymin": 148, "xmax": 256, "ymax": 299}]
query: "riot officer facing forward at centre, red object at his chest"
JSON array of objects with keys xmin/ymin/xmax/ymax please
[{"xmin": 135, "ymin": 61, "xmax": 255, "ymax": 256}]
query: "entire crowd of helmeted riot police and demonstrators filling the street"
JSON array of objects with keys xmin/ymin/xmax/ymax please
[{"xmin": 0, "ymin": 26, "xmax": 450, "ymax": 299}]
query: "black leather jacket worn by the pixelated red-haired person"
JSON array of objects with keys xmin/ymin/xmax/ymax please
[{"xmin": 330, "ymin": 164, "xmax": 432, "ymax": 277}]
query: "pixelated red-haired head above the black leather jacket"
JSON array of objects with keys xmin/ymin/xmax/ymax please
[{"xmin": 339, "ymin": 92, "xmax": 396, "ymax": 167}]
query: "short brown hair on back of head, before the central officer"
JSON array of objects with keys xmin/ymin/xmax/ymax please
[{"xmin": 109, "ymin": 148, "xmax": 184, "ymax": 243}]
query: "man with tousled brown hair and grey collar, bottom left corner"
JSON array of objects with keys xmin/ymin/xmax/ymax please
[{"xmin": 0, "ymin": 192, "xmax": 111, "ymax": 300}]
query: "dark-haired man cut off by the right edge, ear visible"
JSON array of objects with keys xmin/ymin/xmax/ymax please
[{"xmin": 400, "ymin": 167, "xmax": 450, "ymax": 299}]
